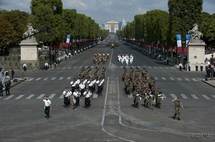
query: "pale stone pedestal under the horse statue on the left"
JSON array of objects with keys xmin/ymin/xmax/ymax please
[{"xmin": 20, "ymin": 36, "xmax": 38, "ymax": 66}]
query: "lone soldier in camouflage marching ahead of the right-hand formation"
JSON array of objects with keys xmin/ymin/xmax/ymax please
[{"xmin": 173, "ymin": 97, "xmax": 183, "ymax": 120}]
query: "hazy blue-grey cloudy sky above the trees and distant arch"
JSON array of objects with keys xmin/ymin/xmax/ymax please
[{"xmin": 0, "ymin": 0, "xmax": 215, "ymax": 24}]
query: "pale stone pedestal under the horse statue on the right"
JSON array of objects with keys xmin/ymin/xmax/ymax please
[{"xmin": 188, "ymin": 40, "xmax": 206, "ymax": 71}]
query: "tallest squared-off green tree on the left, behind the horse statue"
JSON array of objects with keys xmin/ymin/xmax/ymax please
[{"xmin": 31, "ymin": 0, "xmax": 65, "ymax": 45}]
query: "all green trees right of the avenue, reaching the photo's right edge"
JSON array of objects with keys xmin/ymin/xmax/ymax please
[{"xmin": 119, "ymin": 0, "xmax": 215, "ymax": 46}]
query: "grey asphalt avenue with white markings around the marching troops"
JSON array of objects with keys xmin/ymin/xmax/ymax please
[{"xmin": 0, "ymin": 35, "xmax": 215, "ymax": 142}]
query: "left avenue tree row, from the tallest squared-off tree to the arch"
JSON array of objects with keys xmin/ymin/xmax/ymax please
[{"xmin": 31, "ymin": 0, "xmax": 106, "ymax": 45}]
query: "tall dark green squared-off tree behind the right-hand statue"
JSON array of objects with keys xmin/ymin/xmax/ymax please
[{"xmin": 168, "ymin": 0, "xmax": 203, "ymax": 44}]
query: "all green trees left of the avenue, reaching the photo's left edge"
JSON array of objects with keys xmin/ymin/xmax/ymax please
[{"xmin": 0, "ymin": 0, "xmax": 107, "ymax": 54}]
